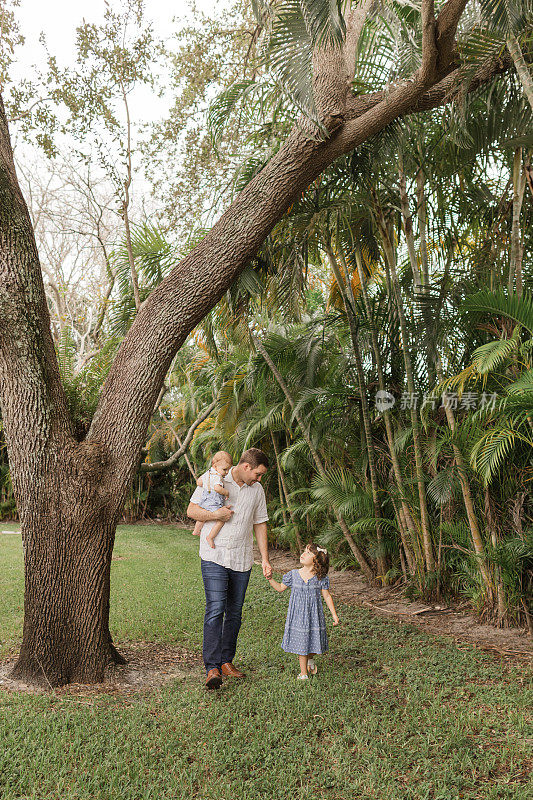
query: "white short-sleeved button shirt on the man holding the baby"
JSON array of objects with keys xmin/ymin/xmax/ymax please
[{"xmin": 191, "ymin": 470, "xmax": 268, "ymax": 572}]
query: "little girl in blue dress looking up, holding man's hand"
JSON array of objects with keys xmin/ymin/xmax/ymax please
[{"xmin": 268, "ymin": 543, "xmax": 339, "ymax": 681}]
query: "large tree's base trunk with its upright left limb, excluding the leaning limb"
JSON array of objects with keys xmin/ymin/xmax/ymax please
[{"xmin": 0, "ymin": 98, "xmax": 123, "ymax": 686}]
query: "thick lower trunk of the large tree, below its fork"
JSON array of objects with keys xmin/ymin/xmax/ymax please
[{"xmin": 9, "ymin": 441, "xmax": 128, "ymax": 687}]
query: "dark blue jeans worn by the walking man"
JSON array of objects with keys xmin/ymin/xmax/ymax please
[{"xmin": 200, "ymin": 558, "xmax": 252, "ymax": 672}]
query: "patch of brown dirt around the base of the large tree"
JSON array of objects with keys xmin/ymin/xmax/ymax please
[{"xmin": 0, "ymin": 642, "xmax": 202, "ymax": 698}]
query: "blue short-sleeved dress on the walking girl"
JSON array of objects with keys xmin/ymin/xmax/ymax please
[{"xmin": 281, "ymin": 569, "xmax": 329, "ymax": 656}]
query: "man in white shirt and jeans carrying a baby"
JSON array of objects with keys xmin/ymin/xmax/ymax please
[{"xmin": 187, "ymin": 447, "xmax": 272, "ymax": 689}]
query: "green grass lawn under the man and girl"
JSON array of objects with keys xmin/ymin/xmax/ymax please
[{"xmin": 0, "ymin": 527, "xmax": 533, "ymax": 800}]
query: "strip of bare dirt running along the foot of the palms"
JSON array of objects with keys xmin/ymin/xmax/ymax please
[{"xmin": 262, "ymin": 550, "xmax": 533, "ymax": 663}]
